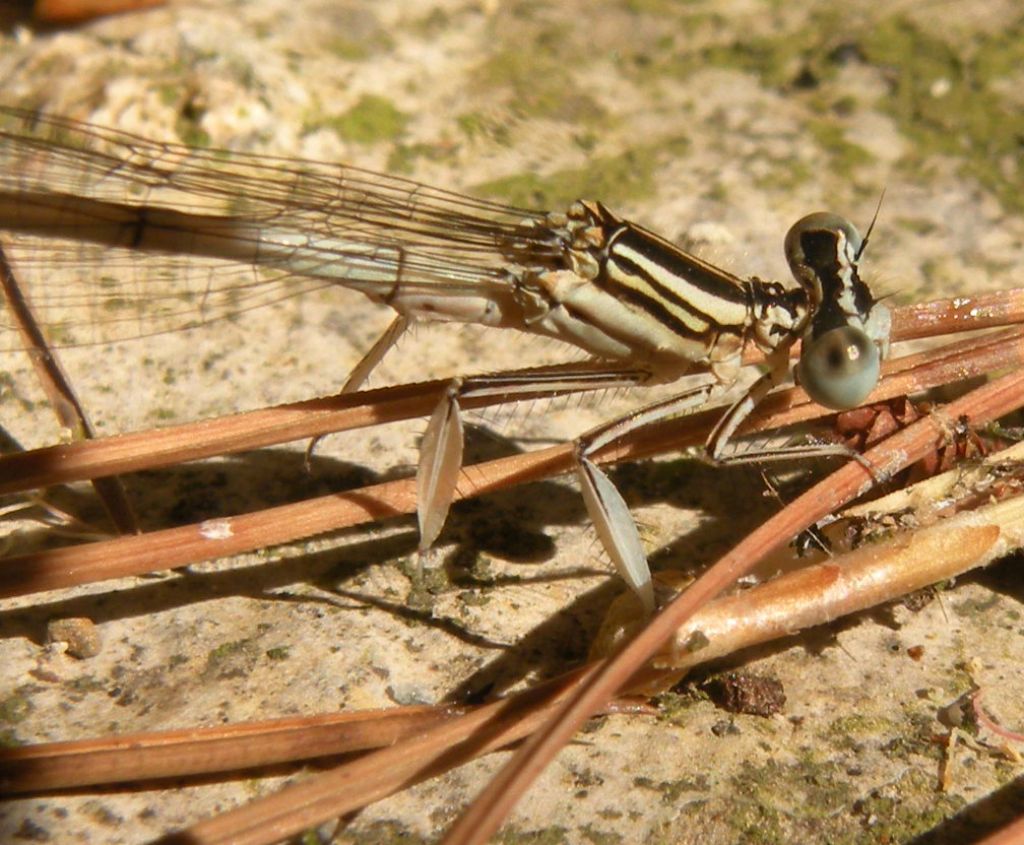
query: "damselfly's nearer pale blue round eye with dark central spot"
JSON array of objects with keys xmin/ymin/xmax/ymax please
[{"xmin": 797, "ymin": 326, "xmax": 882, "ymax": 411}]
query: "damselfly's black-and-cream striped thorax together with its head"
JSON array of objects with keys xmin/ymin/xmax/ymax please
[{"xmin": 503, "ymin": 201, "xmax": 889, "ymax": 408}]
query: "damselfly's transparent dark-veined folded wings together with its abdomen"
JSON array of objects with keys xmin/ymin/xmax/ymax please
[{"xmin": 0, "ymin": 107, "xmax": 558, "ymax": 348}]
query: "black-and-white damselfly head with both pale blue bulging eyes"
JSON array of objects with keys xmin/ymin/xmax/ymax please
[{"xmin": 785, "ymin": 212, "xmax": 889, "ymax": 411}]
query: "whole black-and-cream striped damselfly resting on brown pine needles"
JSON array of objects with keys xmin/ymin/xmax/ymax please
[{"xmin": 0, "ymin": 108, "xmax": 889, "ymax": 607}]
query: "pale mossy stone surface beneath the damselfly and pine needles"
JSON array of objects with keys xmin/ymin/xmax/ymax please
[{"xmin": 0, "ymin": 0, "xmax": 1024, "ymax": 843}]
